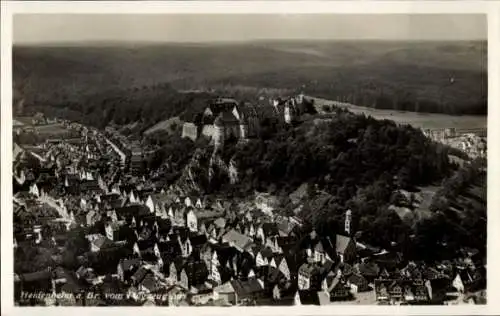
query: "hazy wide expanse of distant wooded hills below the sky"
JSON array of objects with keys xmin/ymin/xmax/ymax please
[{"xmin": 13, "ymin": 41, "xmax": 487, "ymax": 114}]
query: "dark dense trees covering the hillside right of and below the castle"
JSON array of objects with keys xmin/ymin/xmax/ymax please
[{"xmin": 182, "ymin": 109, "xmax": 486, "ymax": 260}]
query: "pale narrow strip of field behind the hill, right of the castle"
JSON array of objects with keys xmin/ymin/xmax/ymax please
[{"xmin": 313, "ymin": 98, "xmax": 488, "ymax": 130}]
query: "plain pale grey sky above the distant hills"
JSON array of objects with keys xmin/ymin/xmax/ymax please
[{"xmin": 13, "ymin": 14, "xmax": 487, "ymax": 44}]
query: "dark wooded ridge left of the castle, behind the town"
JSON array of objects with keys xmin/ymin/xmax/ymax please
[{"xmin": 24, "ymin": 84, "xmax": 213, "ymax": 131}]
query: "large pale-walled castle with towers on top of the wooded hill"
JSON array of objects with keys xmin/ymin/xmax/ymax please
[{"xmin": 182, "ymin": 94, "xmax": 312, "ymax": 147}]
